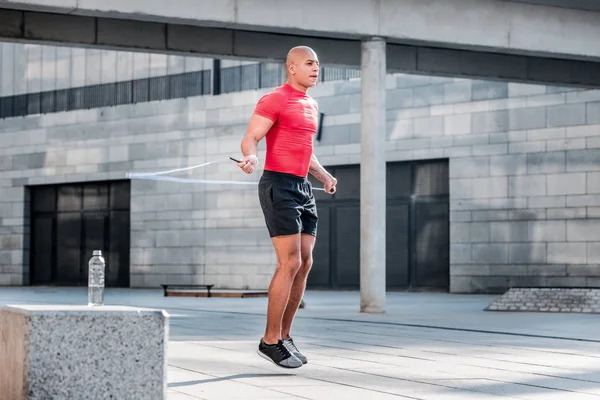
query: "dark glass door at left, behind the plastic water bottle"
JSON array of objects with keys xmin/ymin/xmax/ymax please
[{"xmin": 30, "ymin": 181, "xmax": 130, "ymax": 287}]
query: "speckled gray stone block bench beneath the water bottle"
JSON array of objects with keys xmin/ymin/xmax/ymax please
[{"xmin": 0, "ymin": 305, "xmax": 169, "ymax": 400}]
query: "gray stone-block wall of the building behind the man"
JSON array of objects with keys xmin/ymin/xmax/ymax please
[{"xmin": 0, "ymin": 75, "xmax": 600, "ymax": 292}]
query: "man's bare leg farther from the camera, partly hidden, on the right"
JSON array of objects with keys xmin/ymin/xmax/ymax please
[{"xmin": 281, "ymin": 233, "xmax": 316, "ymax": 339}]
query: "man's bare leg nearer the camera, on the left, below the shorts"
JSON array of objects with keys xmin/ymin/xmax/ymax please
[{"xmin": 263, "ymin": 234, "xmax": 301, "ymax": 344}]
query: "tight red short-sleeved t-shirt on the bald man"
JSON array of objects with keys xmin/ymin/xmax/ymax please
[{"xmin": 254, "ymin": 83, "xmax": 319, "ymax": 177}]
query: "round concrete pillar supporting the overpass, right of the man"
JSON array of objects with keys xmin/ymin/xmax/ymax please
[{"xmin": 360, "ymin": 38, "xmax": 386, "ymax": 313}]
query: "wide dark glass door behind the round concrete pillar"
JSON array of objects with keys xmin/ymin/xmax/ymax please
[{"xmin": 308, "ymin": 160, "xmax": 450, "ymax": 290}]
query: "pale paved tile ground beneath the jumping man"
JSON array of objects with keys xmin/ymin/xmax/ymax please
[{"xmin": 0, "ymin": 288, "xmax": 600, "ymax": 400}]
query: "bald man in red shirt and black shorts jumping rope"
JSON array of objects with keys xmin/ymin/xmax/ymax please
[{"xmin": 238, "ymin": 46, "xmax": 337, "ymax": 368}]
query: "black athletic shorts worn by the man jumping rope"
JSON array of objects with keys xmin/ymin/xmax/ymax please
[{"xmin": 258, "ymin": 171, "xmax": 319, "ymax": 237}]
